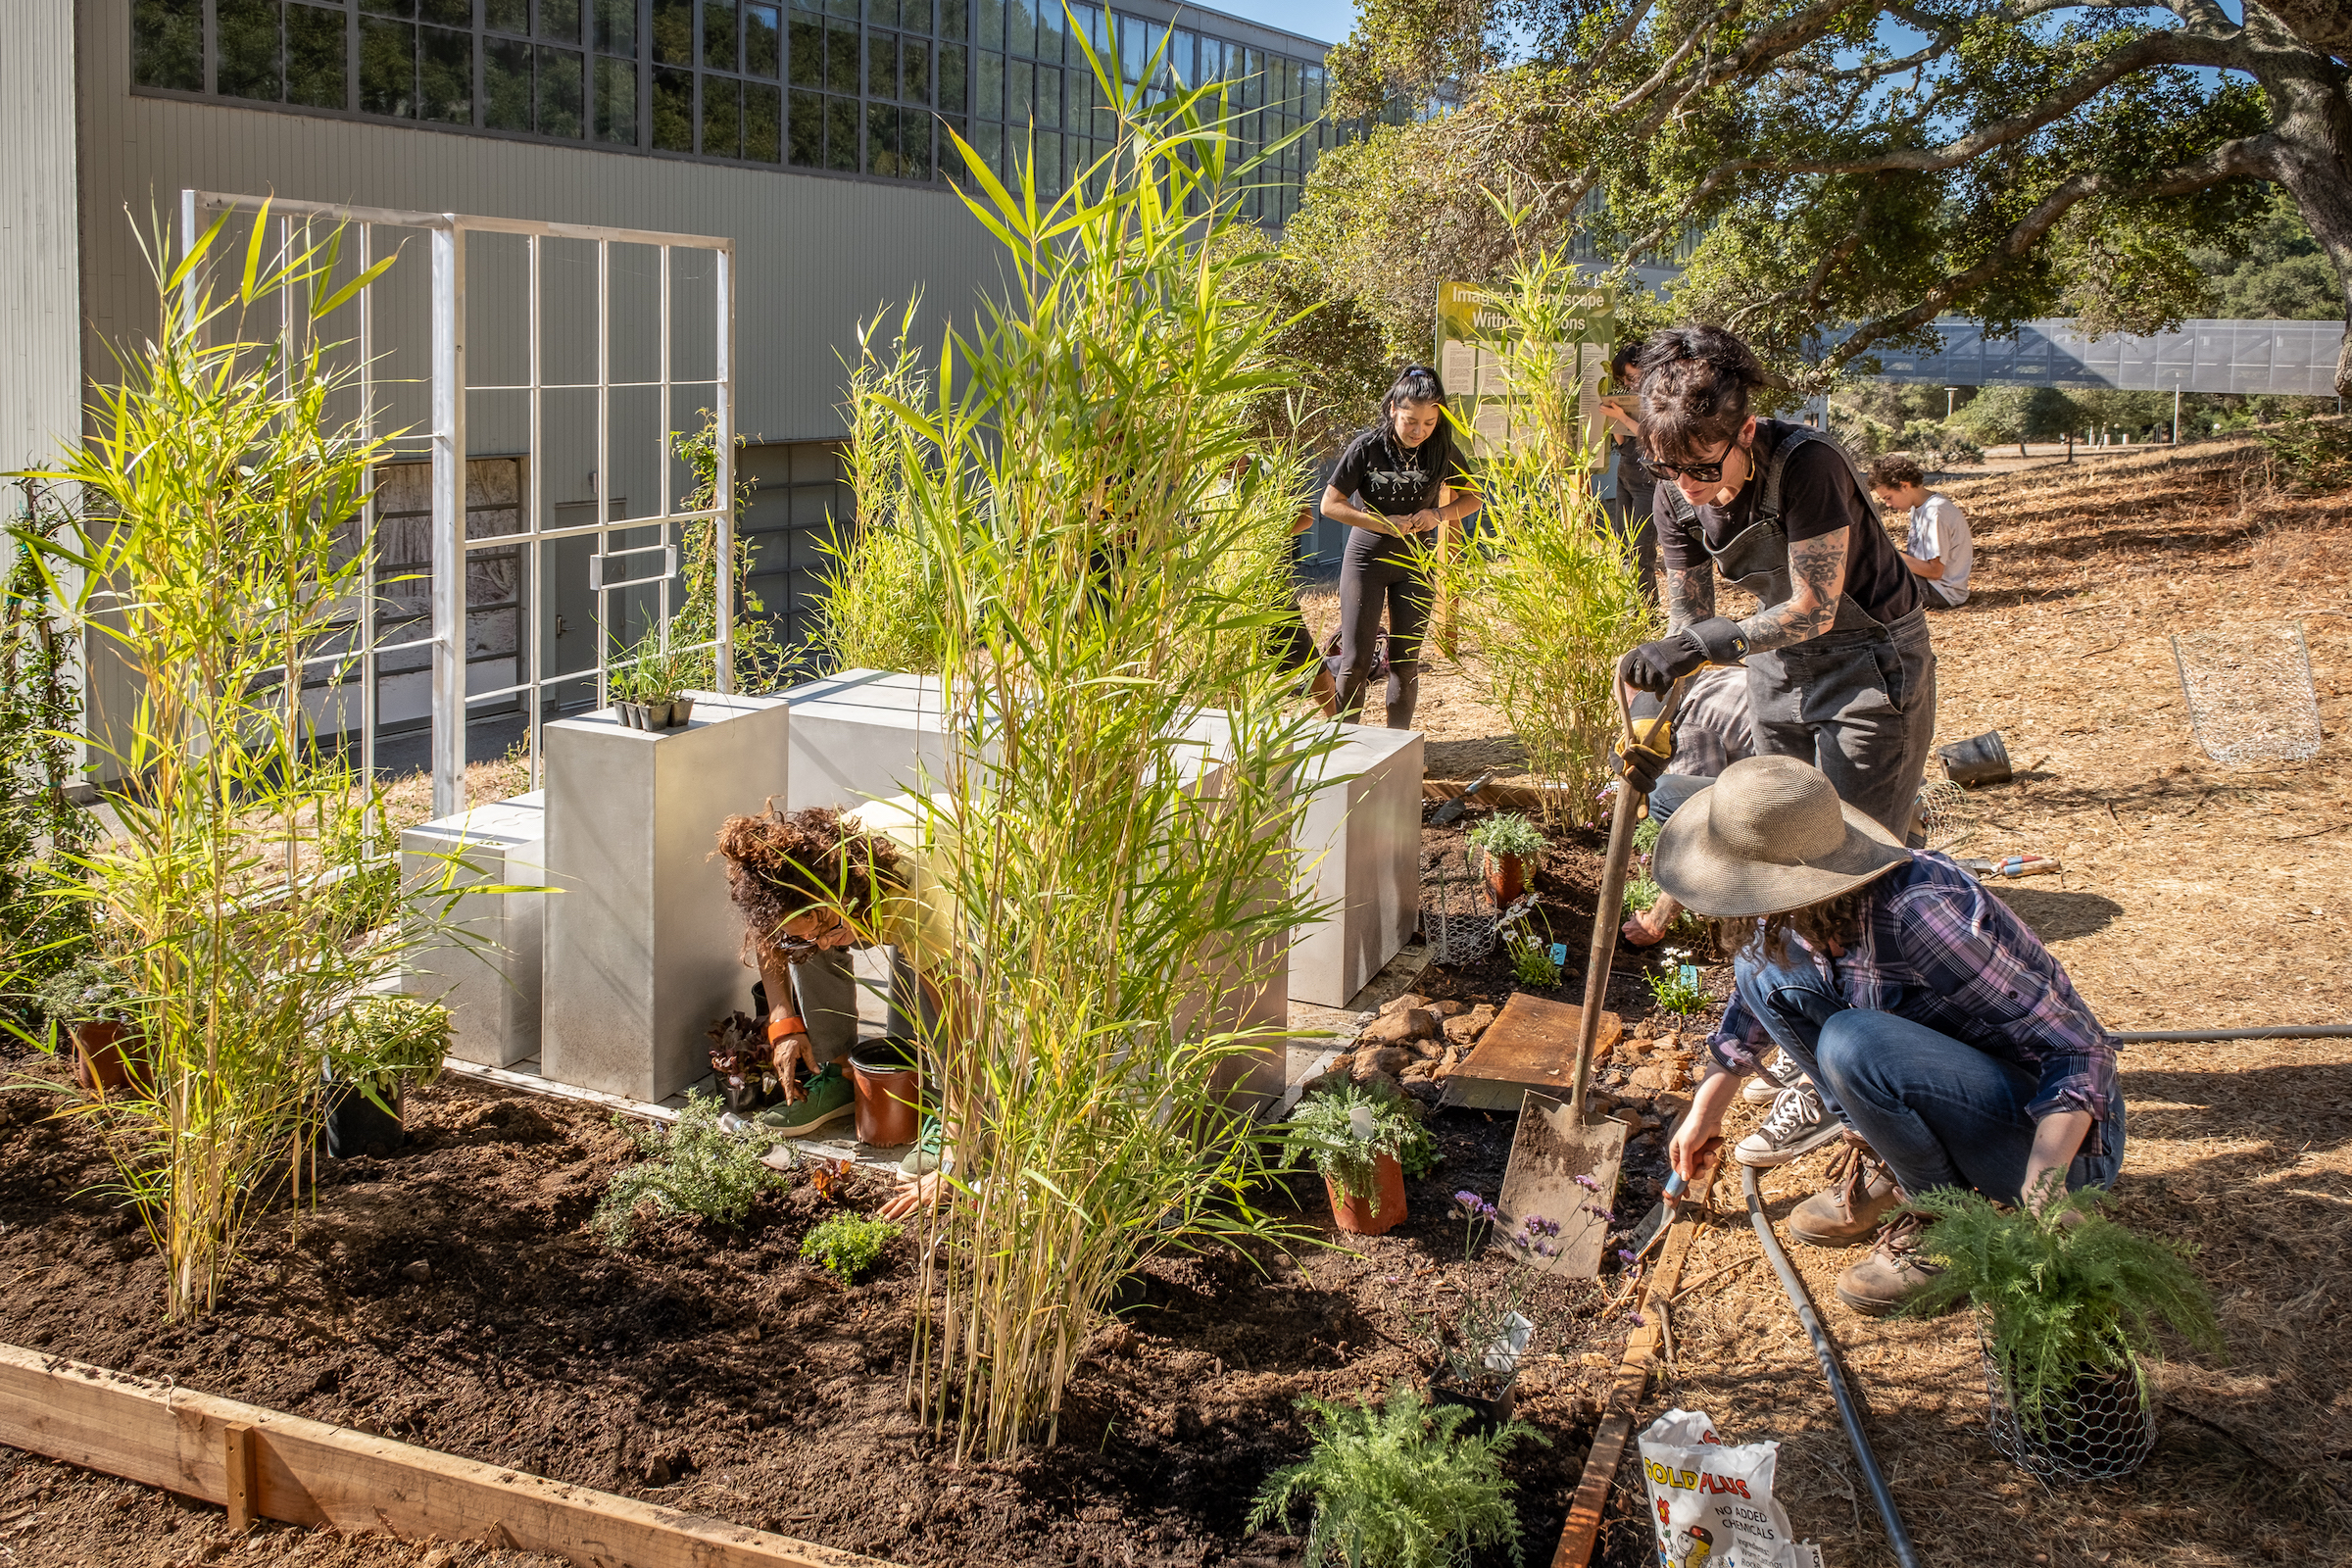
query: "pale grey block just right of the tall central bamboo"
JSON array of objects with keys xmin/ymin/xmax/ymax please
[{"xmin": 1292, "ymin": 724, "xmax": 1423, "ymax": 1006}]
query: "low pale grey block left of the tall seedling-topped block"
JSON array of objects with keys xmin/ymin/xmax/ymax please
[{"xmin": 400, "ymin": 792, "xmax": 548, "ymax": 1067}]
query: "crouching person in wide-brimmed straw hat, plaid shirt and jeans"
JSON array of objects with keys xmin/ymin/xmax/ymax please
[{"xmin": 1651, "ymin": 757, "xmax": 2124, "ymax": 1314}]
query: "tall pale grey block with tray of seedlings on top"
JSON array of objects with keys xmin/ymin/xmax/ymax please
[{"xmin": 541, "ymin": 691, "xmax": 790, "ymax": 1101}]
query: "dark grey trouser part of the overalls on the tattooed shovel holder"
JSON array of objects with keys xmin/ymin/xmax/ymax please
[{"xmin": 1747, "ymin": 609, "xmax": 1936, "ymax": 839}]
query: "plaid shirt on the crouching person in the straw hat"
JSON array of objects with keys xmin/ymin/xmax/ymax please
[{"xmin": 1707, "ymin": 851, "xmax": 2115, "ymax": 1152}]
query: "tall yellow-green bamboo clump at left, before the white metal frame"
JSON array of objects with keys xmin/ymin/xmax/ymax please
[{"xmin": 17, "ymin": 214, "xmax": 508, "ymax": 1319}]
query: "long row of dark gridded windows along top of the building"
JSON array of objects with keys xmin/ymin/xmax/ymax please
[{"xmin": 131, "ymin": 0, "xmax": 1334, "ymax": 219}]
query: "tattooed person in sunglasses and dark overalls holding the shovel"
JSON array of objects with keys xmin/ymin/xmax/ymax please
[{"xmin": 1618, "ymin": 326, "xmax": 1936, "ymax": 839}]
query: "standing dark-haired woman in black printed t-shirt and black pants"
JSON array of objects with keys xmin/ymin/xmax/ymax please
[{"xmin": 1322, "ymin": 365, "xmax": 1480, "ymax": 729}]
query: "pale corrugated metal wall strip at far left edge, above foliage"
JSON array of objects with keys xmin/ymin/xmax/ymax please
[{"xmin": 0, "ymin": 0, "xmax": 83, "ymax": 467}]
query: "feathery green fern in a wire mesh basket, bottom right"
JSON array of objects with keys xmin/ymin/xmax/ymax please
[{"xmin": 1905, "ymin": 1189, "xmax": 2223, "ymax": 1481}]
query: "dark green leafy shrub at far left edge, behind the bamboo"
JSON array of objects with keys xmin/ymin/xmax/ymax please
[{"xmin": 0, "ymin": 479, "xmax": 92, "ymax": 1030}]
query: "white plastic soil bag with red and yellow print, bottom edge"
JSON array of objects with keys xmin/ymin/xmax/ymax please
[{"xmin": 1642, "ymin": 1410, "xmax": 1821, "ymax": 1568}]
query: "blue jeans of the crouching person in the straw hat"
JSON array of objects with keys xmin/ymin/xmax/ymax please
[{"xmin": 1734, "ymin": 953, "xmax": 2124, "ymax": 1203}]
